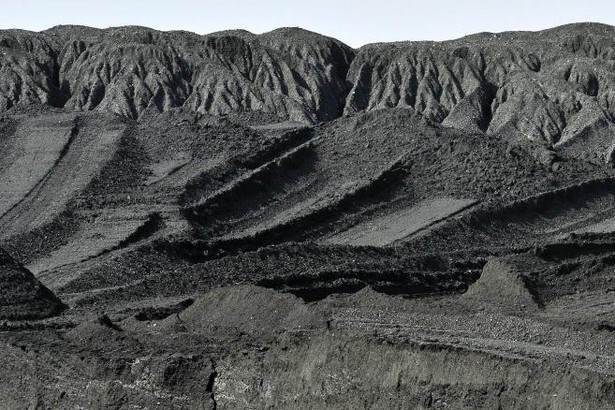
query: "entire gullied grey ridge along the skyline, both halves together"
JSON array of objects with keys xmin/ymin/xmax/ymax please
[{"xmin": 0, "ymin": 24, "xmax": 615, "ymax": 161}]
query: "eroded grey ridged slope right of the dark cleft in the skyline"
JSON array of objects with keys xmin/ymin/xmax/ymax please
[{"xmin": 345, "ymin": 24, "xmax": 615, "ymax": 159}]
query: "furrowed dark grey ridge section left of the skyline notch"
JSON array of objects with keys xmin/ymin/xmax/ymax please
[{"xmin": 0, "ymin": 26, "xmax": 353, "ymax": 122}]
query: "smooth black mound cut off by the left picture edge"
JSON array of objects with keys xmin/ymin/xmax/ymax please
[{"xmin": 0, "ymin": 249, "xmax": 65, "ymax": 320}]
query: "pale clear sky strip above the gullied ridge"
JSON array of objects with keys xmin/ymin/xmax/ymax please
[{"xmin": 0, "ymin": 0, "xmax": 615, "ymax": 47}]
